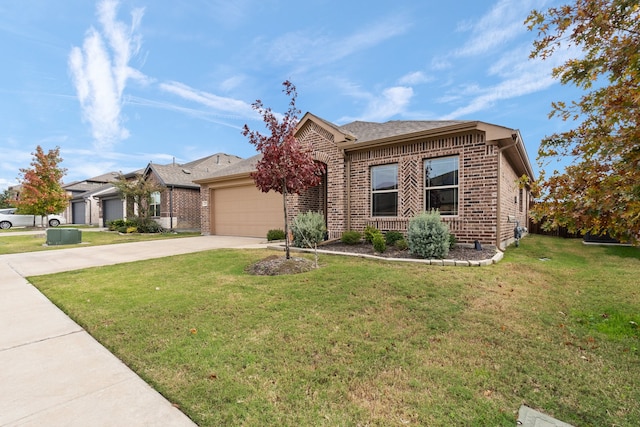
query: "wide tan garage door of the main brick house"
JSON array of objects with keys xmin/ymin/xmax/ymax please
[{"xmin": 210, "ymin": 185, "xmax": 284, "ymax": 237}]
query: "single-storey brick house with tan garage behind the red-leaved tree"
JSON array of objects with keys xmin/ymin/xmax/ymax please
[{"xmin": 197, "ymin": 113, "xmax": 534, "ymax": 248}]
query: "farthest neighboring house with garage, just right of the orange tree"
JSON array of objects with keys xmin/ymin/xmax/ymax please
[{"xmin": 62, "ymin": 172, "xmax": 119, "ymax": 225}]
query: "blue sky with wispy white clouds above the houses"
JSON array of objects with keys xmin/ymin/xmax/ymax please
[{"xmin": 0, "ymin": 0, "xmax": 577, "ymax": 190}]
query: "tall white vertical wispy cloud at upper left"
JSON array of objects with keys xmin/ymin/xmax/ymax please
[{"xmin": 69, "ymin": 0, "xmax": 147, "ymax": 149}]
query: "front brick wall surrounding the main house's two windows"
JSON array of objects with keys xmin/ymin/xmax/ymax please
[{"xmin": 344, "ymin": 132, "xmax": 497, "ymax": 244}]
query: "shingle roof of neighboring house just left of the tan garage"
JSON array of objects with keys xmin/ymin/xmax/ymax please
[{"xmin": 149, "ymin": 153, "xmax": 242, "ymax": 188}]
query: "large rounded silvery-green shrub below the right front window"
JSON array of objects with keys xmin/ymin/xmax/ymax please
[{"xmin": 407, "ymin": 210, "xmax": 449, "ymax": 258}]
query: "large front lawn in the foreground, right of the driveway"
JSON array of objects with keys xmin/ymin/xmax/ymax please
[{"xmin": 30, "ymin": 236, "xmax": 640, "ymax": 426}]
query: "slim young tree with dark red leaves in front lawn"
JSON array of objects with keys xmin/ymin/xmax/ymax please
[{"xmin": 242, "ymin": 80, "xmax": 325, "ymax": 259}]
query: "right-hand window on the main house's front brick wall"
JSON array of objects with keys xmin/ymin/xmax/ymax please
[{"xmin": 424, "ymin": 156, "xmax": 458, "ymax": 215}]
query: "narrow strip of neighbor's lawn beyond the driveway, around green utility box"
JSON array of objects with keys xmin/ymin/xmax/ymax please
[{"xmin": 0, "ymin": 231, "xmax": 200, "ymax": 255}]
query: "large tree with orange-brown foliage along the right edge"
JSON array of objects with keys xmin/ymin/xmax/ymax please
[{"xmin": 526, "ymin": 0, "xmax": 640, "ymax": 244}]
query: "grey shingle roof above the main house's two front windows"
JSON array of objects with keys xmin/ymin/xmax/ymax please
[{"xmin": 338, "ymin": 120, "xmax": 469, "ymax": 143}]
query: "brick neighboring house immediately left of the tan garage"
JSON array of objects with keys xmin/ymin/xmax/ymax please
[{"xmin": 122, "ymin": 153, "xmax": 242, "ymax": 230}]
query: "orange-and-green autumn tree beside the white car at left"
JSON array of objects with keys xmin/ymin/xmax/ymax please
[{"xmin": 16, "ymin": 145, "xmax": 69, "ymax": 225}]
